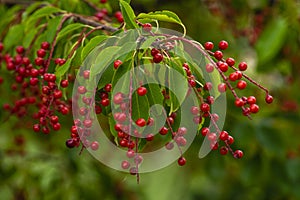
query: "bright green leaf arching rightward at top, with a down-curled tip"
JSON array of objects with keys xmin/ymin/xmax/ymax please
[{"xmin": 137, "ymin": 10, "xmax": 186, "ymax": 33}]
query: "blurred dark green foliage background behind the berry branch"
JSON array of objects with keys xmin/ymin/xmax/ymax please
[{"xmin": 0, "ymin": 0, "xmax": 300, "ymax": 200}]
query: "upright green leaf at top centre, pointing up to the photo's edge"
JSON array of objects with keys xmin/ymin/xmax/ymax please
[{"xmin": 120, "ymin": 0, "xmax": 139, "ymax": 29}]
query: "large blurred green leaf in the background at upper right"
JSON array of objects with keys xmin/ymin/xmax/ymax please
[{"xmin": 255, "ymin": 17, "xmax": 288, "ymax": 65}]
